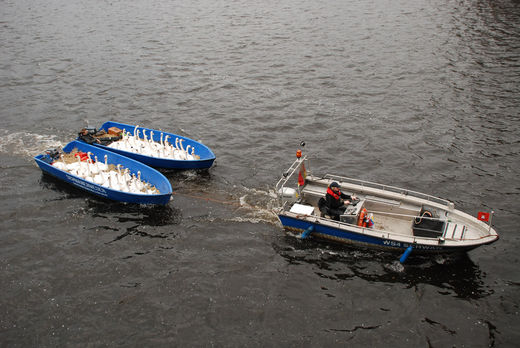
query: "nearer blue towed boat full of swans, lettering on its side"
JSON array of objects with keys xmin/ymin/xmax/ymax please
[{"xmin": 34, "ymin": 140, "xmax": 172, "ymax": 205}]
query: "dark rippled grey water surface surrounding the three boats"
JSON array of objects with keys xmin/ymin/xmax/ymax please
[{"xmin": 0, "ymin": 0, "xmax": 520, "ymax": 347}]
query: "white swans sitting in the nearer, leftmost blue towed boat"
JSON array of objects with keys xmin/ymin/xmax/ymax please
[{"xmin": 52, "ymin": 152, "xmax": 160, "ymax": 195}]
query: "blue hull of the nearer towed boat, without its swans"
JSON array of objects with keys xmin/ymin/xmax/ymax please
[{"xmin": 34, "ymin": 141, "xmax": 172, "ymax": 205}]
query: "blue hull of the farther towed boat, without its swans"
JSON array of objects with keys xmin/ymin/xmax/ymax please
[{"xmin": 87, "ymin": 121, "xmax": 215, "ymax": 169}]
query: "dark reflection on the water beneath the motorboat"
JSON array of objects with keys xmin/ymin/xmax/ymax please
[{"xmin": 273, "ymin": 236, "xmax": 493, "ymax": 299}]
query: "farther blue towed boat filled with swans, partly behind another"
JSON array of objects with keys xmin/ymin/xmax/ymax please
[{"xmin": 79, "ymin": 121, "xmax": 215, "ymax": 169}]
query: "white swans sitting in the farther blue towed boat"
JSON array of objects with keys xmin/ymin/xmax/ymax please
[{"xmin": 108, "ymin": 126, "xmax": 200, "ymax": 161}]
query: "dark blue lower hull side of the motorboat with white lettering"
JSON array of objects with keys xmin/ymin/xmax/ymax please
[{"xmin": 278, "ymin": 214, "xmax": 475, "ymax": 254}]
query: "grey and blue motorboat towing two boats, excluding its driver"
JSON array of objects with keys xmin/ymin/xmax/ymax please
[{"xmin": 275, "ymin": 150, "xmax": 499, "ymax": 259}]
